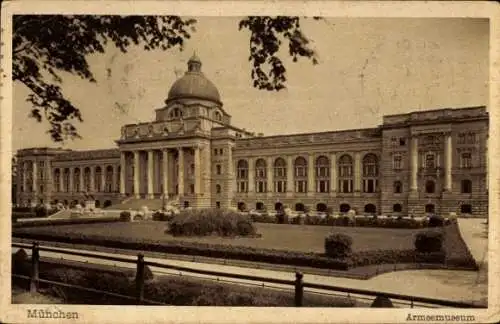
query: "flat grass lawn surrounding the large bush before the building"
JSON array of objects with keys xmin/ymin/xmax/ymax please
[{"xmin": 16, "ymin": 221, "xmax": 422, "ymax": 253}]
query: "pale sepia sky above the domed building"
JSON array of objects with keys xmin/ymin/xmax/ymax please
[{"xmin": 12, "ymin": 17, "xmax": 489, "ymax": 150}]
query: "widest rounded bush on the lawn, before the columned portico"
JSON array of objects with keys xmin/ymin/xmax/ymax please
[{"xmin": 167, "ymin": 208, "xmax": 256, "ymax": 237}]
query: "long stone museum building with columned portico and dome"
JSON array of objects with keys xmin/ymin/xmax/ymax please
[{"xmin": 16, "ymin": 56, "xmax": 489, "ymax": 217}]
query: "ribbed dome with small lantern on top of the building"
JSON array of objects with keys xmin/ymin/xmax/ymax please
[{"xmin": 167, "ymin": 55, "xmax": 221, "ymax": 104}]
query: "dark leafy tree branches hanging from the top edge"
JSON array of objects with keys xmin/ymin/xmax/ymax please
[{"xmin": 12, "ymin": 15, "xmax": 319, "ymax": 142}]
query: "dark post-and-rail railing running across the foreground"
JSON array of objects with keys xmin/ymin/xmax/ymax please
[{"xmin": 12, "ymin": 242, "xmax": 485, "ymax": 308}]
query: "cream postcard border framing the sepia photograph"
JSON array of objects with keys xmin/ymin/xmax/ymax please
[{"xmin": 0, "ymin": 0, "xmax": 500, "ymax": 323}]
